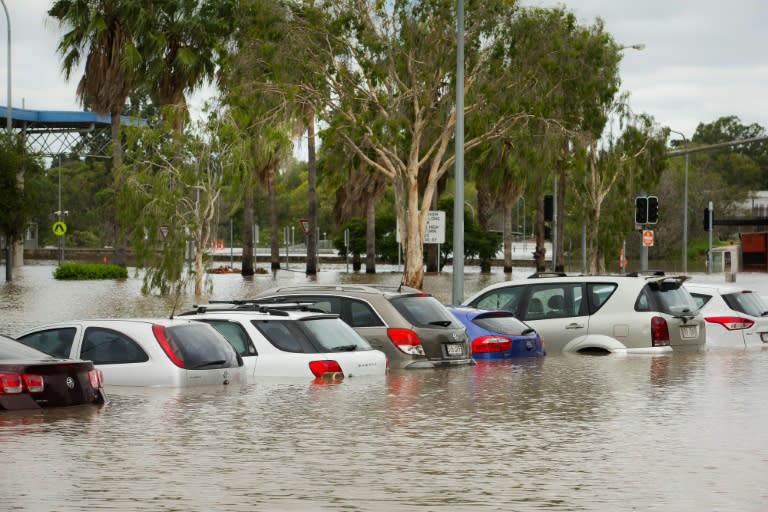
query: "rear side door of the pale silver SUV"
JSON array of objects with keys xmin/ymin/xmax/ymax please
[{"xmin": 518, "ymin": 282, "xmax": 589, "ymax": 353}]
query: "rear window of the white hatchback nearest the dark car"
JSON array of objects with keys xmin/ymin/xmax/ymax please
[{"xmin": 166, "ymin": 323, "xmax": 240, "ymax": 370}]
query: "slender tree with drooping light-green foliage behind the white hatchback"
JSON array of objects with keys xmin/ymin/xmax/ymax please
[{"xmin": 118, "ymin": 112, "xmax": 245, "ymax": 296}]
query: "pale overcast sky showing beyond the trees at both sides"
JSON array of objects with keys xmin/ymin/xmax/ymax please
[{"xmin": 0, "ymin": 0, "xmax": 768, "ymax": 144}]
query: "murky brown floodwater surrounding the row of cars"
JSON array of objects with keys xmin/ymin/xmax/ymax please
[{"xmin": 0, "ymin": 264, "xmax": 768, "ymax": 512}]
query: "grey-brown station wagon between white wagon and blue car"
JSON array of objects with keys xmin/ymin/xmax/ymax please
[{"xmin": 248, "ymin": 284, "xmax": 475, "ymax": 369}]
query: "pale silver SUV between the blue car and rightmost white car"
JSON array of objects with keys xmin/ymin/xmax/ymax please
[{"xmin": 463, "ymin": 272, "xmax": 706, "ymax": 354}]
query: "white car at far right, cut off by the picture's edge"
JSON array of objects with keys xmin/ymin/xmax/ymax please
[{"xmin": 685, "ymin": 281, "xmax": 768, "ymax": 348}]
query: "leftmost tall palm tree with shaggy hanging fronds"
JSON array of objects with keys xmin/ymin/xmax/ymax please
[{"xmin": 48, "ymin": 0, "xmax": 147, "ymax": 266}]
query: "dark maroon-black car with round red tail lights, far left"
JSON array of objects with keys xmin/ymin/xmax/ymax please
[{"xmin": 0, "ymin": 335, "xmax": 107, "ymax": 410}]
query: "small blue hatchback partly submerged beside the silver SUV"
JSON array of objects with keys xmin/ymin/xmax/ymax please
[{"xmin": 448, "ymin": 306, "xmax": 546, "ymax": 360}]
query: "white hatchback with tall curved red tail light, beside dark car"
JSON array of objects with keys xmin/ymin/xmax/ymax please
[{"xmin": 15, "ymin": 318, "xmax": 247, "ymax": 387}]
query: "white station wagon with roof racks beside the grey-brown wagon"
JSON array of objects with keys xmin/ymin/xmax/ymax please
[{"xmin": 177, "ymin": 303, "xmax": 389, "ymax": 380}]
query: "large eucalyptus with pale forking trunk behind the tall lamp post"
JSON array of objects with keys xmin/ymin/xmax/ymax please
[{"xmin": 315, "ymin": 0, "xmax": 540, "ymax": 287}]
